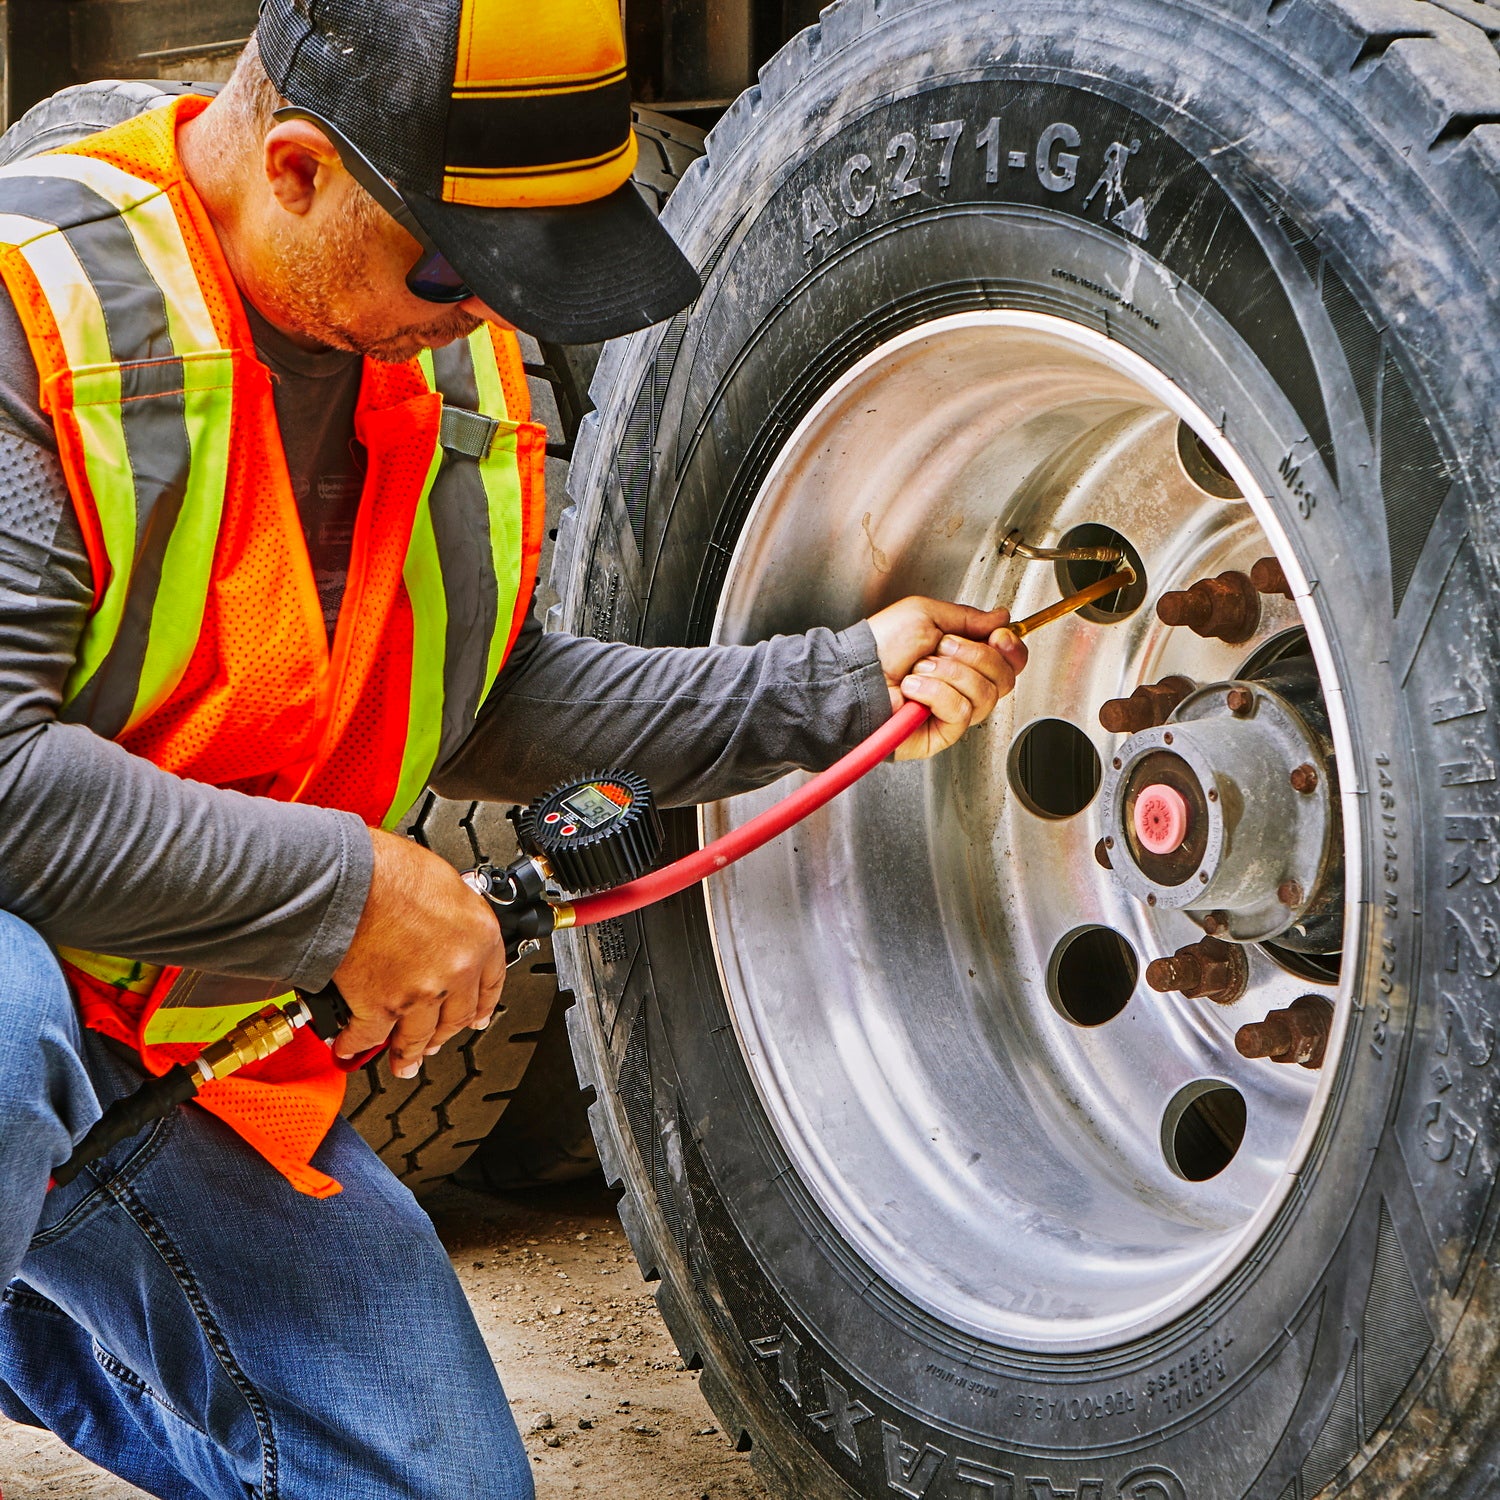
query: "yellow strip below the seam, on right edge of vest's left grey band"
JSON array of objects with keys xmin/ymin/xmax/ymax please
[{"xmin": 126, "ymin": 353, "xmax": 234, "ymax": 729}]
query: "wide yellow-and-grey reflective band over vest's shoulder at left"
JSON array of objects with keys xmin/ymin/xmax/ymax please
[{"xmin": 0, "ymin": 156, "xmax": 234, "ymax": 738}]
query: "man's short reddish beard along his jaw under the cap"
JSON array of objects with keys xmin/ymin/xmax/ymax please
[{"xmin": 267, "ymin": 192, "xmax": 485, "ymax": 365}]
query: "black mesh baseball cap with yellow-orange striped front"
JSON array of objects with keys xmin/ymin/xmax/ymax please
[{"xmin": 257, "ymin": 0, "xmax": 701, "ymax": 344}]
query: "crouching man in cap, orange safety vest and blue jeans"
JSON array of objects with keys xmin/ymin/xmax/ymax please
[{"xmin": 0, "ymin": 0, "xmax": 1025, "ymax": 1500}]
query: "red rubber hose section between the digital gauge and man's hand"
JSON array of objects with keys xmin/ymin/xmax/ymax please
[{"xmin": 558, "ymin": 702, "xmax": 929, "ymax": 927}]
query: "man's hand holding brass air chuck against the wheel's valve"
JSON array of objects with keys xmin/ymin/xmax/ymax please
[{"xmin": 870, "ymin": 596, "xmax": 1026, "ymax": 761}]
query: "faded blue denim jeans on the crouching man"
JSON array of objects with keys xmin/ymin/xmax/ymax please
[{"xmin": 0, "ymin": 912, "xmax": 533, "ymax": 1500}]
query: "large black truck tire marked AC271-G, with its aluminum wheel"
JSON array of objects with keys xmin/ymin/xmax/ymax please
[{"xmin": 552, "ymin": 0, "xmax": 1500, "ymax": 1500}]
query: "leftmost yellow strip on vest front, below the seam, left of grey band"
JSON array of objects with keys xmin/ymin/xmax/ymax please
[{"xmin": 63, "ymin": 365, "xmax": 137, "ymax": 702}]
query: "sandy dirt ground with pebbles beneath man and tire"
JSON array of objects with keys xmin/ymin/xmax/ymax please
[{"xmin": 0, "ymin": 1187, "xmax": 770, "ymax": 1500}]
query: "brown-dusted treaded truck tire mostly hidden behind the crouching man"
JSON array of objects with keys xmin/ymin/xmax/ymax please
[{"xmin": 0, "ymin": 80, "xmax": 702, "ymax": 1196}]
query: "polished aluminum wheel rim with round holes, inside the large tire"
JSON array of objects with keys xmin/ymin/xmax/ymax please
[{"xmin": 701, "ymin": 312, "xmax": 1359, "ymax": 1352}]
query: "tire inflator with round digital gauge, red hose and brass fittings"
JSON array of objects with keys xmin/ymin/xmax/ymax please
[{"xmin": 53, "ymin": 548, "xmax": 1136, "ymax": 1187}]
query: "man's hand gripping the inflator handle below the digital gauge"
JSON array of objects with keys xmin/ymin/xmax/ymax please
[{"xmin": 333, "ymin": 828, "xmax": 506, "ymax": 1079}]
